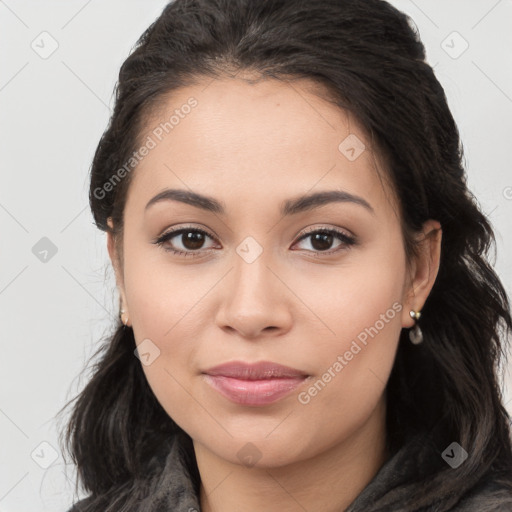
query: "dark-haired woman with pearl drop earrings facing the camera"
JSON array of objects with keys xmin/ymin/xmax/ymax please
[{"xmin": 62, "ymin": 0, "xmax": 512, "ymax": 512}]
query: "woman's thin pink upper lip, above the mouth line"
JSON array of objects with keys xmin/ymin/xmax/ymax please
[{"xmin": 203, "ymin": 361, "xmax": 307, "ymax": 380}]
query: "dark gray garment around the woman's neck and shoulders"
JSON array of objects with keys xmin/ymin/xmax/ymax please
[{"xmin": 68, "ymin": 430, "xmax": 512, "ymax": 512}]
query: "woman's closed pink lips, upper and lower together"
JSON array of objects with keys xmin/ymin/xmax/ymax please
[{"xmin": 203, "ymin": 361, "xmax": 308, "ymax": 405}]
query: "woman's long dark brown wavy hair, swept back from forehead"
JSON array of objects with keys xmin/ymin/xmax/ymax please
[{"xmin": 58, "ymin": 0, "xmax": 512, "ymax": 512}]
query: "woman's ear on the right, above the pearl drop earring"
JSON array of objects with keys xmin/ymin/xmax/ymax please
[{"xmin": 402, "ymin": 219, "xmax": 443, "ymax": 327}]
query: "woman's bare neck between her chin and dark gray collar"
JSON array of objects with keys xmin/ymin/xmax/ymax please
[{"xmin": 194, "ymin": 402, "xmax": 389, "ymax": 512}]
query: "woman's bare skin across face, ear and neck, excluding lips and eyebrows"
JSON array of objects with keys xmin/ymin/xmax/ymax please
[{"xmin": 107, "ymin": 78, "xmax": 441, "ymax": 512}]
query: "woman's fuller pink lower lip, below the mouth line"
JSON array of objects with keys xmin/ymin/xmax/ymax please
[{"xmin": 204, "ymin": 374, "xmax": 306, "ymax": 405}]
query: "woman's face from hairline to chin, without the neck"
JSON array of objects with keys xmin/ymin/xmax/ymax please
[{"xmin": 109, "ymin": 75, "xmax": 436, "ymax": 466}]
